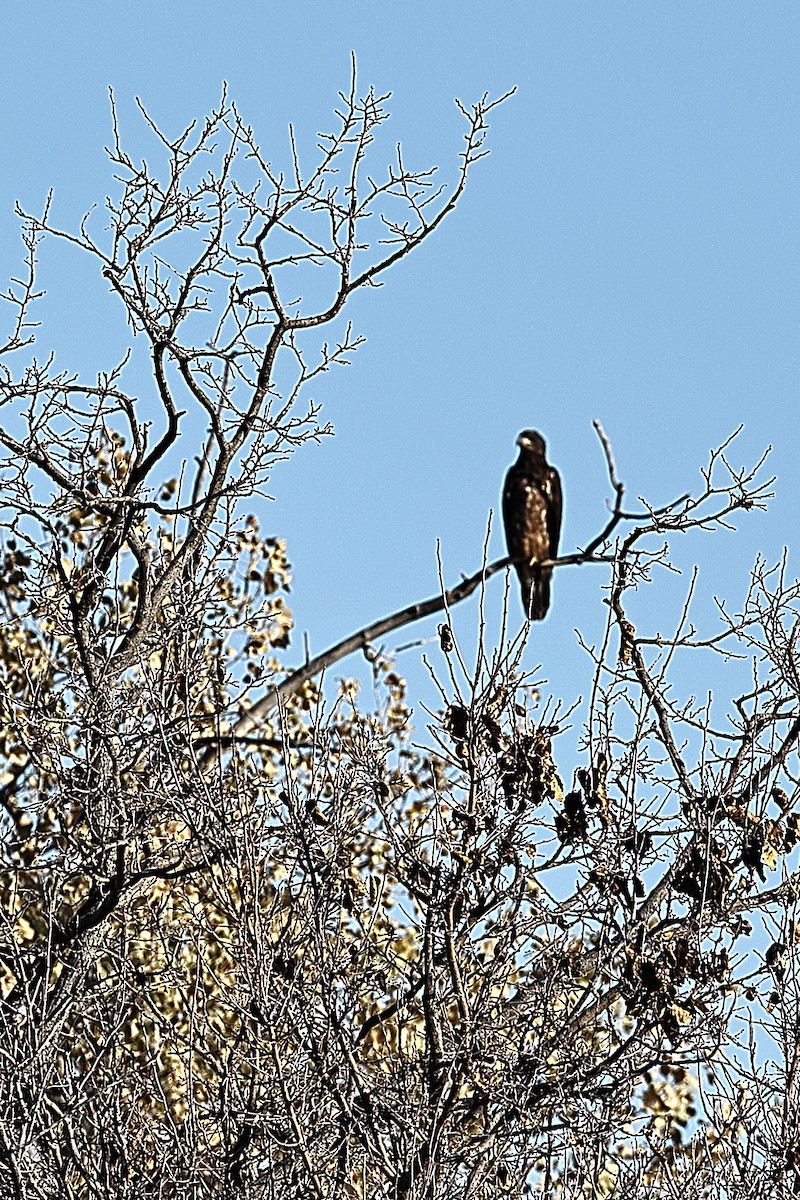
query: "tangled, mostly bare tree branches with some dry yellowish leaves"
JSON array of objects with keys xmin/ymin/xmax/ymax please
[{"xmin": 0, "ymin": 78, "xmax": 800, "ymax": 1200}]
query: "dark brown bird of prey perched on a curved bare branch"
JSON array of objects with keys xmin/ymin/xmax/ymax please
[{"xmin": 503, "ymin": 430, "xmax": 561, "ymax": 620}]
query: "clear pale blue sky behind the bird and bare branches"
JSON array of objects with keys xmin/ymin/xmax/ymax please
[{"xmin": 0, "ymin": 0, "xmax": 800, "ymax": 729}]
